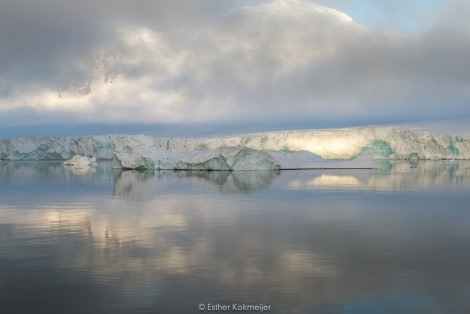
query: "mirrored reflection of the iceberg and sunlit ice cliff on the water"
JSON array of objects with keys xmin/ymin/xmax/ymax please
[{"xmin": 110, "ymin": 161, "xmax": 470, "ymax": 200}]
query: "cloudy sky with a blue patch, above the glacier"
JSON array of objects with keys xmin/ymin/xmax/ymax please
[{"xmin": 0, "ymin": 0, "xmax": 470, "ymax": 136}]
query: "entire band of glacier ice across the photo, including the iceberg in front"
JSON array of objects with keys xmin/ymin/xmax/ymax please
[{"xmin": 0, "ymin": 127, "xmax": 470, "ymax": 170}]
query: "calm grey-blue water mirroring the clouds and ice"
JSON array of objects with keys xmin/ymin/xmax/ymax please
[{"xmin": 0, "ymin": 161, "xmax": 470, "ymax": 314}]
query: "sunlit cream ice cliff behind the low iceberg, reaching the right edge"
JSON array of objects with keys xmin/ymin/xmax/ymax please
[{"xmin": 150, "ymin": 127, "xmax": 470, "ymax": 160}]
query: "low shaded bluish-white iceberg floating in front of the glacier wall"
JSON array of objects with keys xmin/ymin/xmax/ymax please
[{"xmin": 113, "ymin": 135, "xmax": 375, "ymax": 171}]
